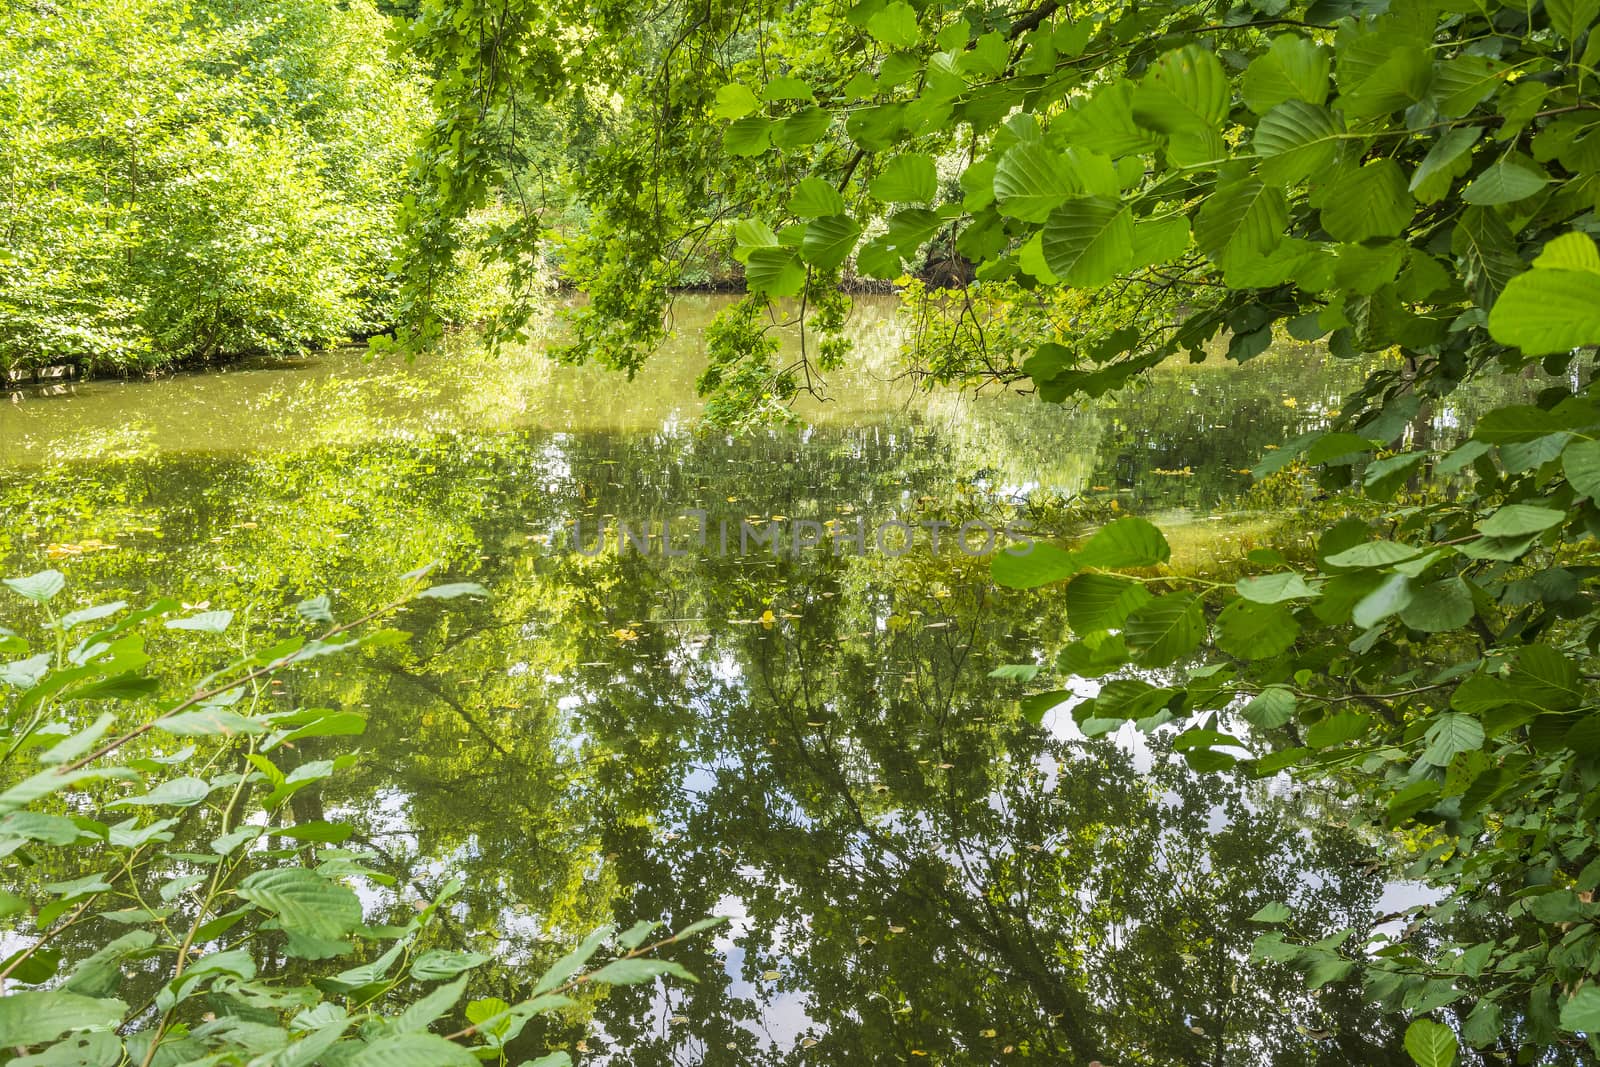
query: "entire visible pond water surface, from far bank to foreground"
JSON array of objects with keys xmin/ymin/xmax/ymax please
[{"xmin": 0, "ymin": 298, "xmax": 1548, "ymax": 1067}]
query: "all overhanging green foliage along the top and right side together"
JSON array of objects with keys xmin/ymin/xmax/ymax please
[{"xmin": 390, "ymin": 0, "xmax": 1600, "ymax": 1062}]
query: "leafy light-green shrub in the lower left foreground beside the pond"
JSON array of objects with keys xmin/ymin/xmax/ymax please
[{"xmin": 0, "ymin": 571, "xmax": 720, "ymax": 1067}]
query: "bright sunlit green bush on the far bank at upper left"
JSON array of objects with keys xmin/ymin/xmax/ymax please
[{"xmin": 0, "ymin": 0, "xmax": 427, "ymax": 371}]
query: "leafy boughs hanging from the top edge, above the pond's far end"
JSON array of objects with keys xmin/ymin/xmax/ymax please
[{"xmin": 387, "ymin": 0, "xmax": 1600, "ymax": 419}]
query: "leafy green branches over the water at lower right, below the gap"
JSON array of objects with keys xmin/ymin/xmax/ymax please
[{"xmin": 994, "ymin": 499, "xmax": 1600, "ymax": 1062}]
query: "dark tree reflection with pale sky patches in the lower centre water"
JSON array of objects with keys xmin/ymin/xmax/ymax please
[{"xmin": 544, "ymin": 547, "xmax": 1403, "ymax": 1064}]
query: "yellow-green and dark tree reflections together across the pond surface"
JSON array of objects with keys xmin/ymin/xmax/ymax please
[{"xmin": 6, "ymin": 383, "xmax": 1536, "ymax": 1067}]
